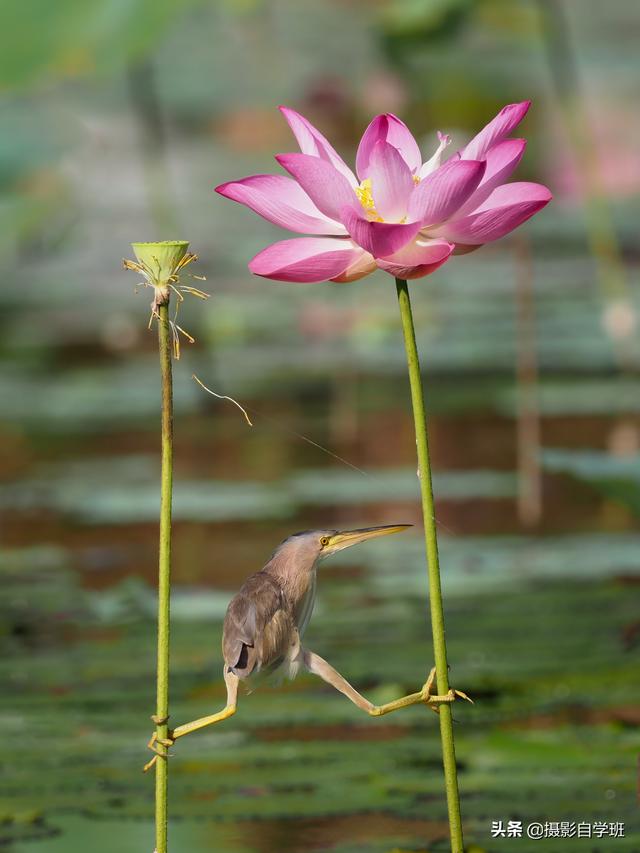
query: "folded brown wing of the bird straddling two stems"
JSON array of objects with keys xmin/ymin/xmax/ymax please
[{"xmin": 222, "ymin": 572, "xmax": 295, "ymax": 678}]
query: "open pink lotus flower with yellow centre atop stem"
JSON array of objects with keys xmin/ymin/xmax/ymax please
[{"xmin": 216, "ymin": 101, "xmax": 551, "ymax": 282}]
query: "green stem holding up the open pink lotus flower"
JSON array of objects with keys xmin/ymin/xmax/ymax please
[{"xmin": 396, "ymin": 278, "xmax": 464, "ymax": 853}]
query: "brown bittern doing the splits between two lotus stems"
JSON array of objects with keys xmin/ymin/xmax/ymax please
[{"xmin": 144, "ymin": 524, "xmax": 472, "ymax": 771}]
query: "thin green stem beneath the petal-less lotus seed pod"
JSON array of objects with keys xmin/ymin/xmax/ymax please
[{"xmin": 156, "ymin": 300, "xmax": 173, "ymax": 853}]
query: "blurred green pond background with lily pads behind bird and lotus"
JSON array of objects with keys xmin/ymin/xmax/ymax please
[{"xmin": 0, "ymin": 0, "xmax": 640, "ymax": 853}]
